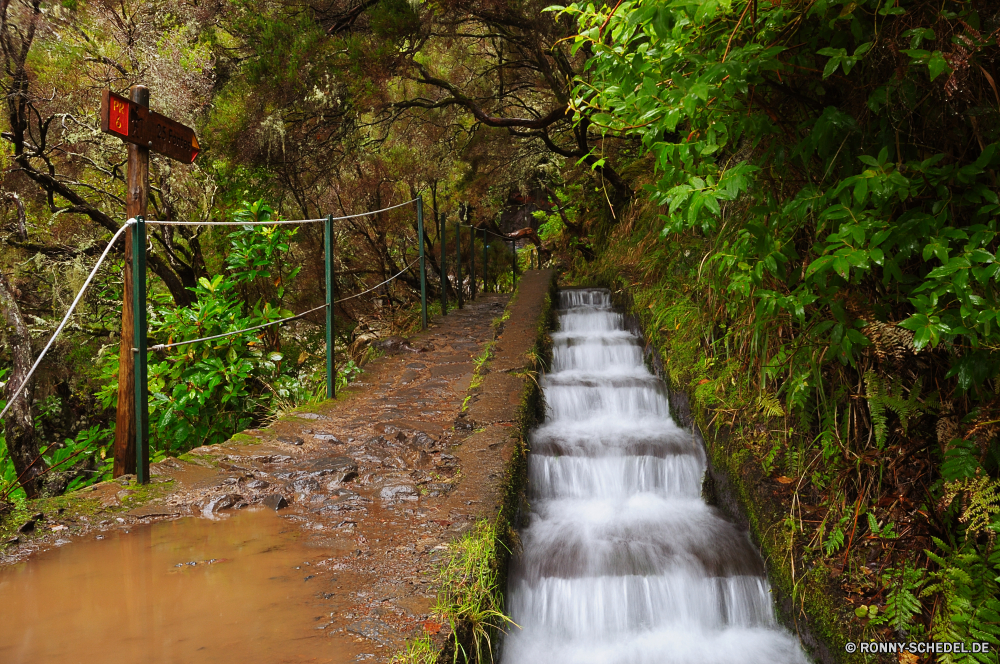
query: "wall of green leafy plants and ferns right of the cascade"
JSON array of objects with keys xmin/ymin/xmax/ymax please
[{"xmin": 556, "ymin": 0, "xmax": 1000, "ymax": 661}]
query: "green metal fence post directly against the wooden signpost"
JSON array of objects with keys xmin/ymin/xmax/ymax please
[{"xmin": 132, "ymin": 216, "xmax": 149, "ymax": 484}]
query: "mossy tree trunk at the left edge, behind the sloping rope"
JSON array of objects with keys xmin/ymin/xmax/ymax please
[{"xmin": 0, "ymin": 273, "xmax": 45, "ymax": 498}]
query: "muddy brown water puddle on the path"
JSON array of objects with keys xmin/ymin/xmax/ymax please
[{"xmin": 0, "ymin": 510, "xmax": 356, "ymax": 664}]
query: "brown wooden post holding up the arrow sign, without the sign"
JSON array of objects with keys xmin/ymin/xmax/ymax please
[{"xmin": 113, "ymin": 85, "xmax": 149, "ymax": 477}]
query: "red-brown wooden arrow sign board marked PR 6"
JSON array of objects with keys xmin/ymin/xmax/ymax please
[{"xmin": 101, "ymin": 90, "xmax": 201, "ymax": 164}]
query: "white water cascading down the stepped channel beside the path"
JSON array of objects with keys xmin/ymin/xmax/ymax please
[{"xmin": 502, "ymin": 290, "xmax": 807, "ymax": 664}]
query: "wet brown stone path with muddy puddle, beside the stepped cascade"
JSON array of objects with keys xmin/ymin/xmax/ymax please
[{"xmin": 0, "ymin": 271, "xmax": 552, "ymax": 663}]
